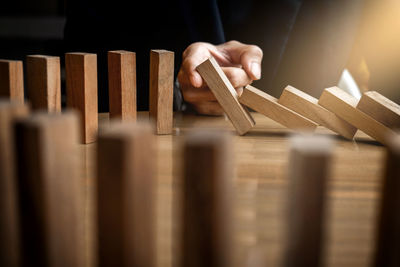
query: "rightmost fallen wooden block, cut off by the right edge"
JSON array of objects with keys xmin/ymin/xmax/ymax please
[{"xmin": 357, "ymin": 91, "xmax": 400, "ymax": 129}]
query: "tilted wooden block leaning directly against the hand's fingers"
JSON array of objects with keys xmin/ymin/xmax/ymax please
[{"xmin": 196, "ymin": 57, "xmax": 255, "ymax": 135}]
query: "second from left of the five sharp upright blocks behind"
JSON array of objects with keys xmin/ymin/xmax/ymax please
[{"xmin": 26, "ymin": 55, "xmax": 61, "ymax": 112}]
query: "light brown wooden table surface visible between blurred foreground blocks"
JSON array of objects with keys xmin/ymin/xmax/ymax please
[{"xmin": 81, "ymin": 113, "xmax": 385, "ymax": 267}]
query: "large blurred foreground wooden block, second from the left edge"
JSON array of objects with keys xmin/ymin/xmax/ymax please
[{"xmin": 15, "ymin": 112, "xmax": 86, "ymax": 266}]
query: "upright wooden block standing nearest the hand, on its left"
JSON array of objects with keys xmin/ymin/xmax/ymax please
[{"xmin": 149, "ymin": 50, "xmax": 174, "ymax": 134}]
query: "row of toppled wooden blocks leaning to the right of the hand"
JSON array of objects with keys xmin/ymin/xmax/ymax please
[{"xmin": 197, "ymin": 58, "xmax": 400, "ymax": 144}]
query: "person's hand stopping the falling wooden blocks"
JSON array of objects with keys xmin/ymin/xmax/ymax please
[{"xmin": 178, "ymin": 41, "xmax": 263, "ymax": 115}]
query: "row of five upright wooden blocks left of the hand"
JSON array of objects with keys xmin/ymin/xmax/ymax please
[{"xmin": 0, "ymin": 50, "xmax": 174, "ymax": 144}]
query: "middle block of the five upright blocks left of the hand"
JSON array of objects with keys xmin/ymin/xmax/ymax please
[{"xmin": 65, "ymin": 53, "xmax": 98, "ymax": 144}]
